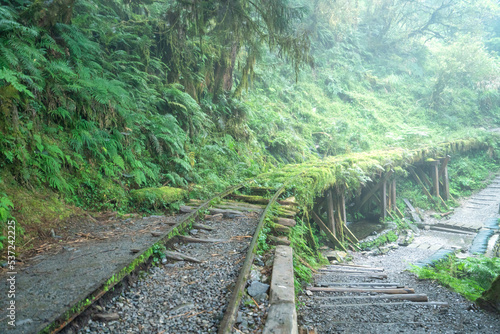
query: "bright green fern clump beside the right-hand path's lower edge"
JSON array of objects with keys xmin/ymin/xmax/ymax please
[{"xmin": 411, "ymin": 256, "xmax": 500, "ymax": 301}]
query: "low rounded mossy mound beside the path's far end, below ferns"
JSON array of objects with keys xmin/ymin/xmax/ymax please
[{"xmin": 130, "ymin": 187, "xmax": 188, "ymax": 210}]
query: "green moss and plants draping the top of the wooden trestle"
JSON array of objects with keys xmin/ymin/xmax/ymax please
[{"xmin": 257, "ymin": 138, "xmax": 488, "ymax": 209}]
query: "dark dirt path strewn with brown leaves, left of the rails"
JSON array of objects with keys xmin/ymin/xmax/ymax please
[{"xmin": 0, "ymin": 215, "xmax": 186, "ymax": 333}]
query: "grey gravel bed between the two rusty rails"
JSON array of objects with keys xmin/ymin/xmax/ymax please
[{"xmin": 73, "ymin": 212, "xmax": 259, "ymax": 334}]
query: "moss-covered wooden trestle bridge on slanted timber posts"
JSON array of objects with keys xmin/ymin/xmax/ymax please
[{"xmin": 259, "ymin": 139, "xmax": 490, "ymax": 250}]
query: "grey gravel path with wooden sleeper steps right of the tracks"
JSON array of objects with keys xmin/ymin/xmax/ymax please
[{"xmin": 299, "ymin": 177, "xmax": 500, "ymax": 333}]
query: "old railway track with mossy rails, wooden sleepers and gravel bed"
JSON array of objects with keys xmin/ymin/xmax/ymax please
[{"xmin": 49, "ymin": 185, "xmax": 296, "ymax": 333}]
